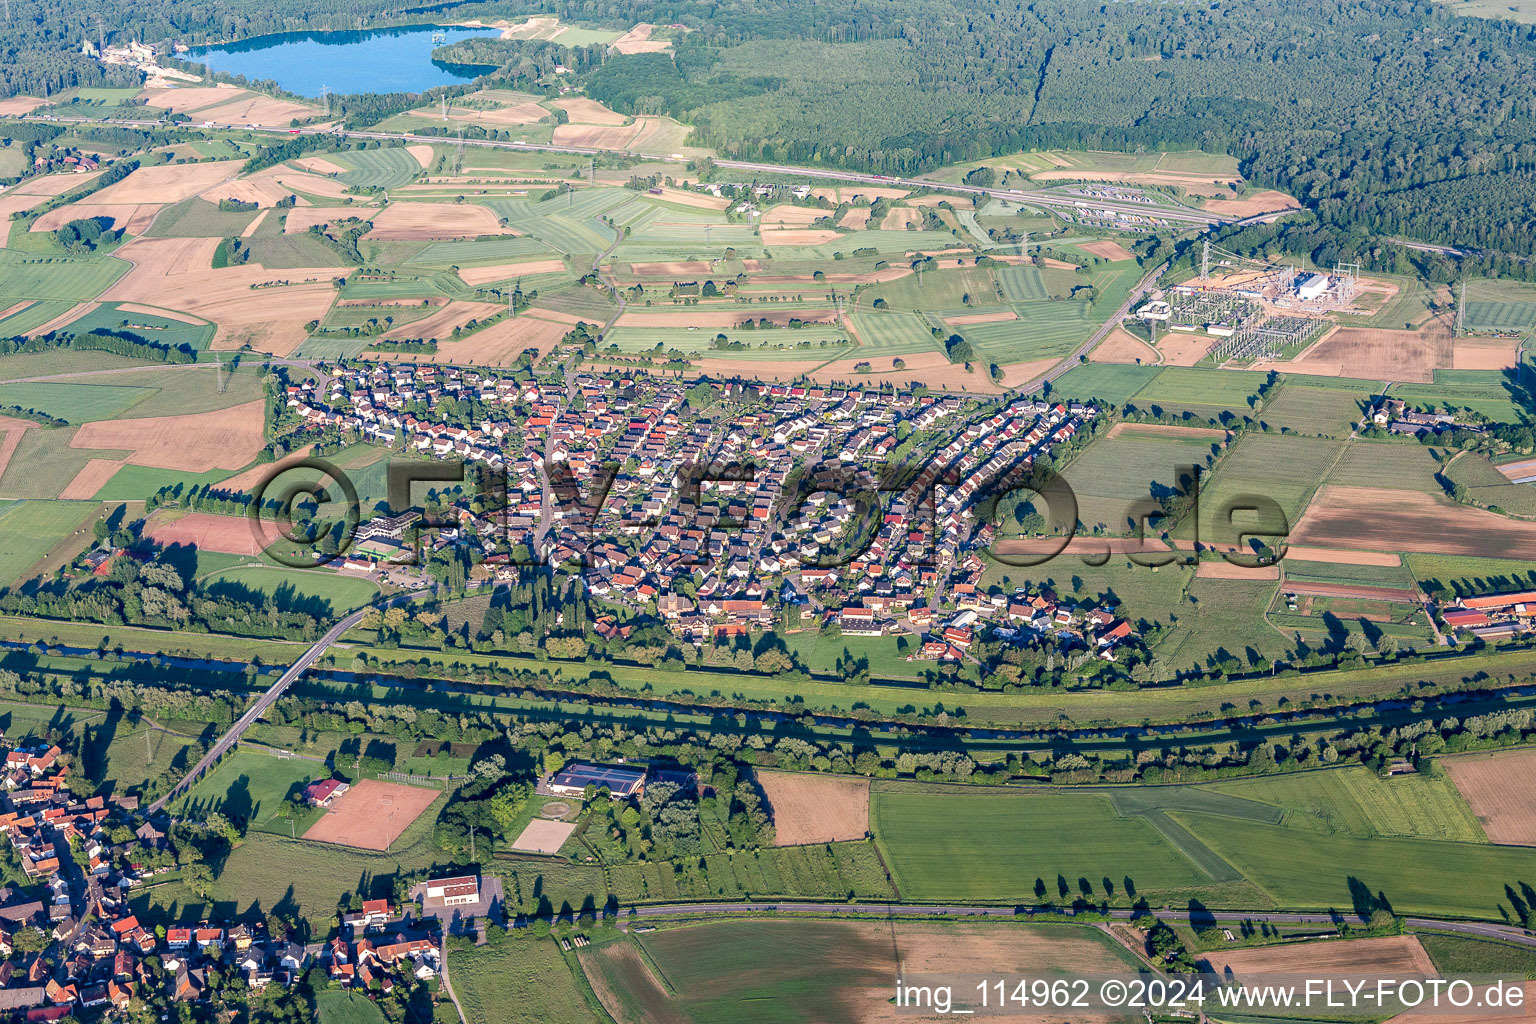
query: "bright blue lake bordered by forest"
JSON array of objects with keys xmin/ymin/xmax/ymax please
[{"xmin": 184, "ymin": 25, "xmax": 498, "ymax": 97}]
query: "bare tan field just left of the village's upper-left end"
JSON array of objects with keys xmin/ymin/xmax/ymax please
[{"xmin": 69, "ymin": 399, "xmax": 266, "ymax": 473}]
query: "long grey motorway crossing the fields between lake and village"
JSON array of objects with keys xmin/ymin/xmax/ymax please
[{"xmin": 22, "ymin": 115, "xmax": 1222, "ymax": 227}]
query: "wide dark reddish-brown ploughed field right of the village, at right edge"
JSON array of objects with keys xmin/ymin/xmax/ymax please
[{"xmin": 1290, "ymin": 484, "xmax": 1536, "ymax": 560}]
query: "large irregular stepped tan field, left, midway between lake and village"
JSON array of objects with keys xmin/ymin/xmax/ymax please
[{"xmin": 103, "ymin": 238, "xmax": 336, "ymax": 356}]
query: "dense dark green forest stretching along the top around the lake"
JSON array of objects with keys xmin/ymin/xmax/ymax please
[{"xmin": 9, "ymin": 0, "xmax": 1536, "ymax": 256}]
